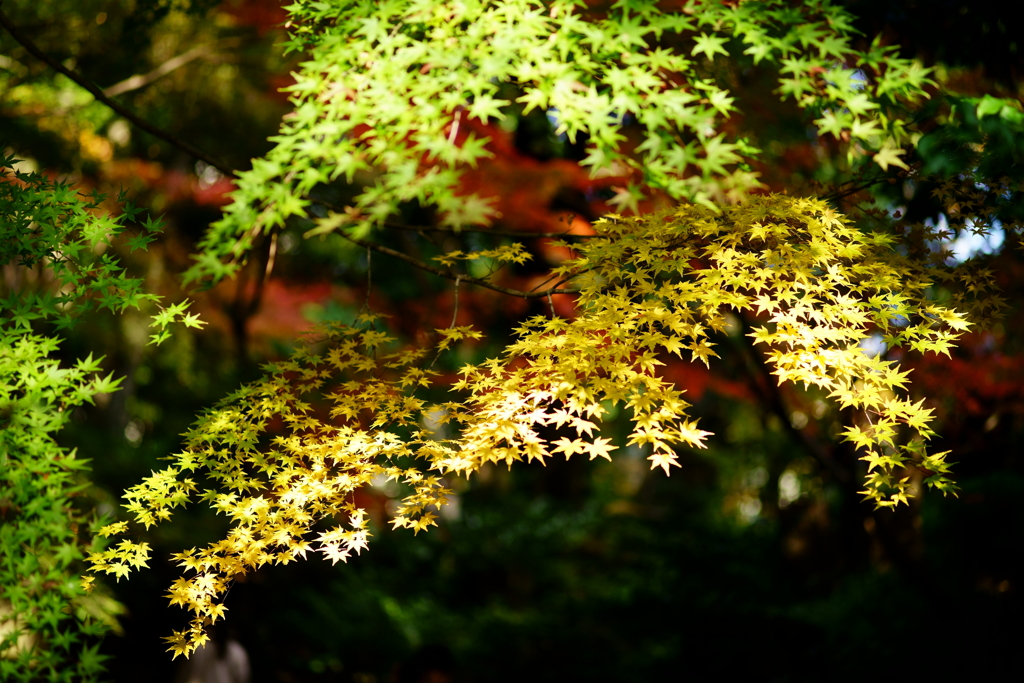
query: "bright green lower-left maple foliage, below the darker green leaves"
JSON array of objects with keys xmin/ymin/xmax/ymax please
[{"xmin": 0, "ymin": 326, "xmax": 109, "ymax": 681}]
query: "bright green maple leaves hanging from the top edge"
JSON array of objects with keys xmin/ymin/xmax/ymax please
[{"xmin": 188, "ymin": 0, "xmax": 927, "ymax": 280}]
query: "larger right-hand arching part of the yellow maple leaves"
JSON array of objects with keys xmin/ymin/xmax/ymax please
[{"xmin": 471, "ymin": 196, "xmax": 983, "ymax": 506}]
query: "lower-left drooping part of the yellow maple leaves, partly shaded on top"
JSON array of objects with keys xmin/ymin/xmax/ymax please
[{"xmin": 90, "ymin": 328, "xmax": 449, "ymax": 655}]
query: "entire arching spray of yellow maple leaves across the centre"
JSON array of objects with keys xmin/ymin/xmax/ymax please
[{"xmin": 92, "ymin": 196, "xmax": 989, "ymax": 654}]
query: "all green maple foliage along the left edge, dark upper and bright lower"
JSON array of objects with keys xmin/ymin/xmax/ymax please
[{"xmin": 0, "ymin": 157, "xmax": 198, "ymax": 681}]
